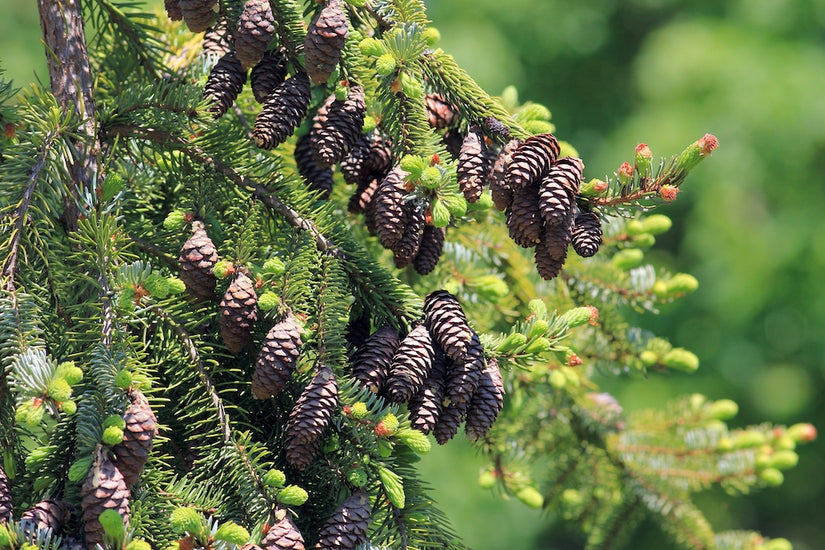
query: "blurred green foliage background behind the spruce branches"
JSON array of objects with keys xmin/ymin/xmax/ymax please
[{"xmin": 0, "ymin": 0, "xmax": 825, "ymax": 550}]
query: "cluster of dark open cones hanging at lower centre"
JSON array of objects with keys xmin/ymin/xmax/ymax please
[{"xmin": 352, "ymin": 290, "xmax": 504, "ymax": 445}]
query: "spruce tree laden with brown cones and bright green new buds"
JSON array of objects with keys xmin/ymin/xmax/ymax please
[{"xmin": 0, "ymin": 0, "xmax": 816, "ymax": 550}]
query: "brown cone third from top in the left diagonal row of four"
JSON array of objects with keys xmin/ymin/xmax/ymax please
[{"xmin": 252, "ymin": 313, "xmax": 302, "ymax": 399}]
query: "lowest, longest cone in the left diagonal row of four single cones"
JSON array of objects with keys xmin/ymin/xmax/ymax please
[{"xmin": 284, "ymin": 365, "xmax": 338, "ymax": 470}]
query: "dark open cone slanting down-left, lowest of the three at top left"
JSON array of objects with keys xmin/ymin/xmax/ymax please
[{"xmin": 252, "ymin": 73, "xmax": 310, "ymax": 149}]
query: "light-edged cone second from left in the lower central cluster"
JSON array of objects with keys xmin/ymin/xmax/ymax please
[{"xmin": 386, "ymin": 324, "xmax": 435, "ymax": 403}]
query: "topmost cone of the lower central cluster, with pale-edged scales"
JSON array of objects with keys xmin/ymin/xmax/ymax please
[{"xmin": 424, "ymin": 290, "xmax": 473, "ymax": 361}]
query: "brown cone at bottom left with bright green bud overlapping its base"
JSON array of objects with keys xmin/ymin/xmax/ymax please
[{"xmin": 80, "ymin": 447, "xmax": 129, "ymax": 550}]
